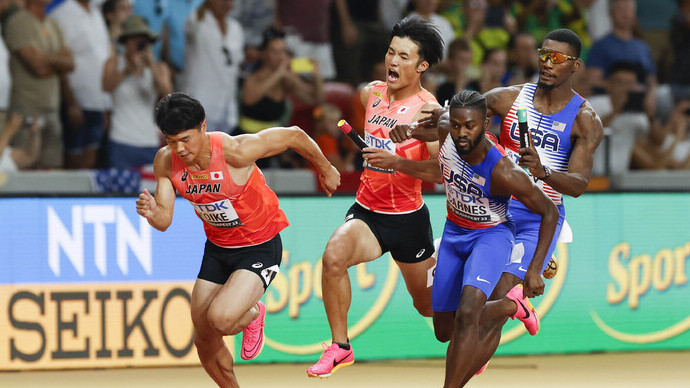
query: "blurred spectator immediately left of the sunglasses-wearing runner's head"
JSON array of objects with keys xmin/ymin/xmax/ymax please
[{"xmin": 506, "ymin": 32, "xmax": 539, "ymax": 85}]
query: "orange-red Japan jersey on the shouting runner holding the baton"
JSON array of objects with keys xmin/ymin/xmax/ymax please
[{"xmin": 357, "ymin": 82, "xmax": 436, "ymax": 214}]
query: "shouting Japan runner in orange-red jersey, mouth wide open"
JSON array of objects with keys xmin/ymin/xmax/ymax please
[{"xmin": 307, "ymin": 17, "xmax": 443, "ymax": 377}]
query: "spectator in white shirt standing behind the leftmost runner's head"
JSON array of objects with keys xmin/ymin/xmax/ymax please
[{"xmin": 181, "ymin": 0, "xmax": 244, "ymax": 133}]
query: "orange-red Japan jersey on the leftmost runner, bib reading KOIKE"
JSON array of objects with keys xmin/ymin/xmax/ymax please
[{"xmin": 172, "ymin": 133, "xmax": 290, "ymax": 248}]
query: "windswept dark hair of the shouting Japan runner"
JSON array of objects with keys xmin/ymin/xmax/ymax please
[{"xmin": 391, "ymin": 16, "xmax": 443, "ymax": 66}]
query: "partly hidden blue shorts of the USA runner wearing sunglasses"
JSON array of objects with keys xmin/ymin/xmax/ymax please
[{"xmin": 503, "ymin": 199, "xmax": 565, "ymax": 280}]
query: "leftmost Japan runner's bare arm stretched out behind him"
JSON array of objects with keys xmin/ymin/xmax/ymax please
[{"xmin": 223, "ymin": 126, "xmax": 340, "ymax": 196}]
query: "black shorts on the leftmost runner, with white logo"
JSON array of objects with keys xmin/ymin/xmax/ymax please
[{"xmin": 198, "ymin": 234, "xmax": 283, "ymax": 289}]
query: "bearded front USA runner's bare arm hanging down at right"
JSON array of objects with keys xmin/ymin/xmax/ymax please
[{"xmin": 491, "ymin": 158, "xmax": 558, "ymax": 297}]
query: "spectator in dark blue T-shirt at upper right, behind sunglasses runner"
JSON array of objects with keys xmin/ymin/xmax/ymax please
[{"xmin": 587, "ymin": 0, "xmax": 657, "ymax": 116}]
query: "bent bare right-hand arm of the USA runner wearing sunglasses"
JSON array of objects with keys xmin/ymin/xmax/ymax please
[{"xmin": 533, "ymin": 103, "xmax": 604, "ymax": 197}]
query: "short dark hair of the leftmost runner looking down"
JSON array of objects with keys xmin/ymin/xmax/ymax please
[{"xmin": 156, "ymin": 92, "xmax": 206, "ymax": 136}]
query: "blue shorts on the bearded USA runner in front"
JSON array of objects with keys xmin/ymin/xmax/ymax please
[{"xmin": 431, "ymin": 220, "xmax": 514, "ymax": 312}]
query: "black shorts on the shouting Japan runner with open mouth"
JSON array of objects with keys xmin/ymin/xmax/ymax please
[{"xmin": 345, "ymin": 203, "xmax": 434, "ymax": 263}]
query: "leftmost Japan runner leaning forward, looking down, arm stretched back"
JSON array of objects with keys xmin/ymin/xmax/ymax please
[{"xmin": 137, "ymin": 93, "xmax": 340, "ymax": 388}]
